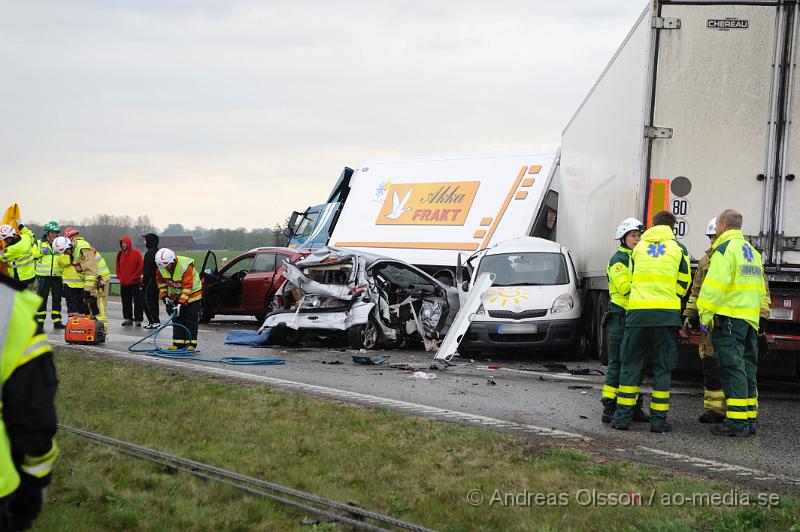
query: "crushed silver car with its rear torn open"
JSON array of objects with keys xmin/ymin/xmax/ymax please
[{"xmin": 262, "ymin": 247, "xmax": 458, "ymax": 350}]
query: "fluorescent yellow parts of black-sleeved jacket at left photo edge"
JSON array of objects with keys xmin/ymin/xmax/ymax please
[{"xmin": 0, "ymin": 284, "xmax": 58, "ymax": 498}]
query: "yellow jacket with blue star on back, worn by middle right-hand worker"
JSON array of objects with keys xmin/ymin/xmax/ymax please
[{"xmin": 628, "ymin": 225, "xmax": 692, "ymax": 313}]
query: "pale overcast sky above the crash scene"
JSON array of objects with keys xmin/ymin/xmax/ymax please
[{"xmin": 0, "ymin": 0, "xmax": 645, "ymax": 228}]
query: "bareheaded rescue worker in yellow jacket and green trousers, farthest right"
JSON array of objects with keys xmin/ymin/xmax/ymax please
[{"xmin": 697, "ymin": 209, "xmax": 769, "ymax": 437}]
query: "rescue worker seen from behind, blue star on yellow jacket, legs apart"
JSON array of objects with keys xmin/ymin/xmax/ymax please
[{"xmin": 611, "ymin": 211, "xmax": 691, "ymax": 433}]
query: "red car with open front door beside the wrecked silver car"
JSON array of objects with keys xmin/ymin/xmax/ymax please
[{"xmin": 200, "ymin": 247, "xmax": 308, "ymax": 323}]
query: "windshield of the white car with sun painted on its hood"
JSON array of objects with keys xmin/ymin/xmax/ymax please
[{"xmin": 476, "ymin": 252, "xmax": 569, "ymax": 286}]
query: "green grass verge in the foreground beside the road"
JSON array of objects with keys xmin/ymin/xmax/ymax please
[{"xmin": 38, "ymin": 350, "xmax": 800, "ymax": 531}]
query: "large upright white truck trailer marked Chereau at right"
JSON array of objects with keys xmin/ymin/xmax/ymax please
[{"xmin": 555, "ymin": 0, "xmax": 800, "ymax": 376}]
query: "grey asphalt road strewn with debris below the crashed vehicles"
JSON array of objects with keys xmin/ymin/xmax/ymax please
[{"xmin": 46, "ymin": 300, "xmax": 800, "ymax": 493}]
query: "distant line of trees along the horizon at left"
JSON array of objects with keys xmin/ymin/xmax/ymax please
[{"xmin": 27, "ymin": 214, "xmax": 286, "ymax": 251}]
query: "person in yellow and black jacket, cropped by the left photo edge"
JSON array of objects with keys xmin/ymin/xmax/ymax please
[{"xmin": 0, "ymin": 275, "xmax": 58, "ymax": 530}]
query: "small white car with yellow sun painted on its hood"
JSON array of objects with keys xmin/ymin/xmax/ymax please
[{"xmin": 454, "ymin": 237, "xmax": 586, "ymax": 354}]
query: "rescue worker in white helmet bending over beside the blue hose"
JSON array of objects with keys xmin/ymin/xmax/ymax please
[{"xmin": 155, "ymin": 248, "xmax": 203, "ymax": 351}]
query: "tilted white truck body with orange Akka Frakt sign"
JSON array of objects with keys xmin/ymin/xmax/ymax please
[{"xmin": 330, "ymin": 151, "xmax": 559, "ymax": 284}]
